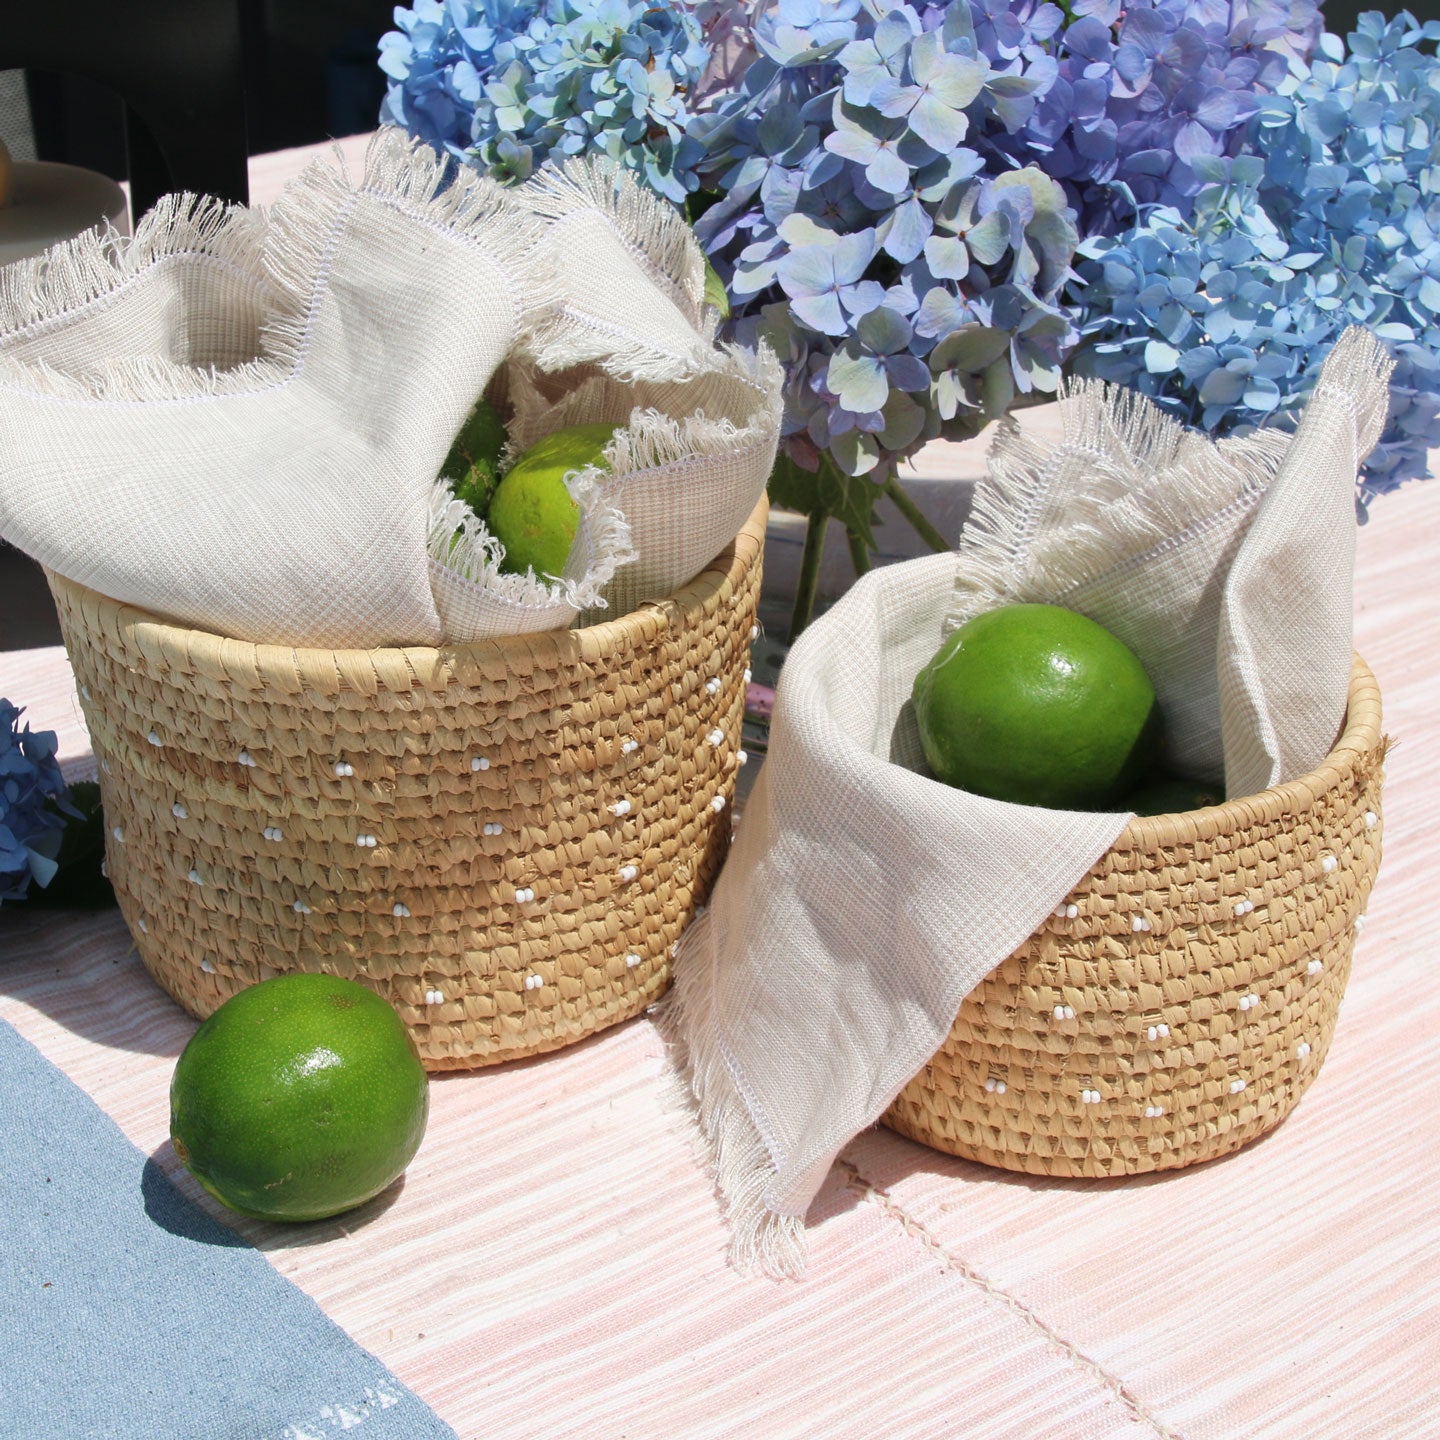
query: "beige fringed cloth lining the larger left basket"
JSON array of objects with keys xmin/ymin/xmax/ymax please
[{"xmin": 0, "ymin": 130, "xmax": 780, "ymax": 648}]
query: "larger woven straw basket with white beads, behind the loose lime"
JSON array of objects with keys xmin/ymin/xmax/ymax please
[{"xmin": 49, "ymin": 500, "xmax": 765, "ymax": 1070}]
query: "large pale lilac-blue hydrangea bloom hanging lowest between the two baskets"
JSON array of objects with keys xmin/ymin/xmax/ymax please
[{"xmin": 691, "ymin": 0, "xmax": 1079, "ymax": 478}]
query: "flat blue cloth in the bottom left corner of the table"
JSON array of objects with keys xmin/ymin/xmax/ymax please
[{"xmin": 0, "ymin": 1021, "xmax": 455, "ymax": 1440}]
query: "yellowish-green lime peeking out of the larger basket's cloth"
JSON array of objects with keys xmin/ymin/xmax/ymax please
[{"xmin": 487, "ymin": 425, "xmax": 618, "ymax": 579}]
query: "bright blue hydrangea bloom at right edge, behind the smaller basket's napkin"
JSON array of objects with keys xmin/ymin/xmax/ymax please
[{"xmin": 1074, "ymin": 13, "xmax": 1440, "ymax": 504}]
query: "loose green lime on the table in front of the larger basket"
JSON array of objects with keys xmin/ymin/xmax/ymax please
[{"xmin": 170, "ymin": 975, "xmax": 429, "ymax": 1220}]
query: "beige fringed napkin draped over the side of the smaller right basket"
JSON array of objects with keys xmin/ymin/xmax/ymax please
[{"xmin": 660, "ymin": 330, "xmax": 1390, "ymax": 1273}]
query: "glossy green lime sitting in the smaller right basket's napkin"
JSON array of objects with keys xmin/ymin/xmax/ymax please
[{"xmin": 913, "ymin": 605, "xmax": 1162, "ymax": 809}]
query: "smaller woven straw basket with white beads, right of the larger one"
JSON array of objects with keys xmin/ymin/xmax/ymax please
[{"xmin": 884, "ymin": 657, "xmax": 1385, "ymax": 1175}]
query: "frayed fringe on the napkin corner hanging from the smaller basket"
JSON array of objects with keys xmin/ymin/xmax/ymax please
[{"xmin": 651, "ymin": 914, "xmax": 808, "ymax": 1280}]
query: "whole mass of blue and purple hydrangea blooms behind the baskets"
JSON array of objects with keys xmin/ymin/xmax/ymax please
[{"xmin": 382, "ymin": 0, "xmax": 1440, "ymax": 506}]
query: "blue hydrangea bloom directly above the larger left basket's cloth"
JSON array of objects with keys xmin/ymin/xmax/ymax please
[{"xmin": 380, "ymin": 0, "xmax": 710, "ymax": 203}]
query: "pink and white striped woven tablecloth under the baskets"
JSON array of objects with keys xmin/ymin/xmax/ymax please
[{"xmin": 0, "ymin": 141, "xmax": 1440, "ymax": 1440}]
